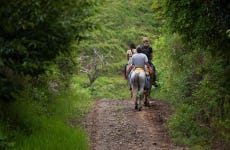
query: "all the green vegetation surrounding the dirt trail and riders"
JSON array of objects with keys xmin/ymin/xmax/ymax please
[{"xmin": 0, "ymin": 0, "xmax": 230, "ymax": 149}]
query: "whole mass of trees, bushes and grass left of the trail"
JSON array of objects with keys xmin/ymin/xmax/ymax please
[{"xmin": 0, "ymin": 0, "xmax": 100, "ymax": 149}]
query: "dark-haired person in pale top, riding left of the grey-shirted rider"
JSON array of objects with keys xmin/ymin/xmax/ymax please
[{"xmin": 124, "ymin": 43, "xmax": 137, "ymax": 79}]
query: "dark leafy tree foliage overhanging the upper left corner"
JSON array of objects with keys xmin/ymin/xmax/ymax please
[{"xmin": 0, "ymin": 0, "xmax": 98, "ymax": 100}]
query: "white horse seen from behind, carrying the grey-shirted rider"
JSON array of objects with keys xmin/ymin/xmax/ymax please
[{"xmin": 130, "ymin": 68, "xmax": 146, "ymax": 111}]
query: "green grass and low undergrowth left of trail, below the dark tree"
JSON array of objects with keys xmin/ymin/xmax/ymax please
[{"xmin": 0, "ymin": 75, "xmax": 93, "ymax": 150}]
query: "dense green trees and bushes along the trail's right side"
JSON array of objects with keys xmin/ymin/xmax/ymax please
[{"xmin": 150, "ymin": 0, "xmax": 230, "ymax": 148}]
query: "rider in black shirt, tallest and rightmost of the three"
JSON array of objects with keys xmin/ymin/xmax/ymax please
[{"xmin": 142, "ymin": 37, "xmax": 158, "ymax": 87}]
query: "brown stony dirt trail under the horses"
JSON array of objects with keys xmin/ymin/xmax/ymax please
[{"xmin": 85, "ymin": 99, "xmax": 186, "ymax": 150}]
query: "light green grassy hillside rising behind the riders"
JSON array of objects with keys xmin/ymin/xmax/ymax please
[{"xmin": 77, "ymin": 0, "xmax": 157, "ymax": 77}]
